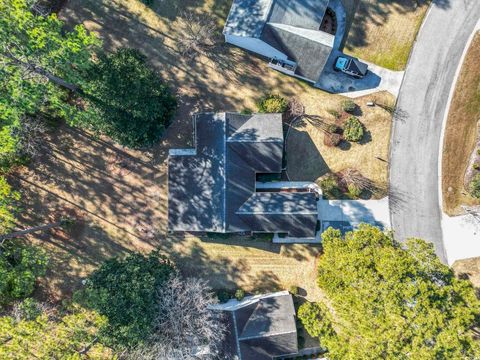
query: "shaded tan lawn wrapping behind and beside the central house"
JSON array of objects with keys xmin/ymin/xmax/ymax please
[{"xmin": 13, "ymin": 0, "xmax": 352, "ymax": 300}]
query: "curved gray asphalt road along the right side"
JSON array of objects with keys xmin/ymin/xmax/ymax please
[{"xmin": 390, "ymin": 0, "xmax": 480, "ymax": 263}]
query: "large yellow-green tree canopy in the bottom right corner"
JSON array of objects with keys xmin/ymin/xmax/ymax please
[{"xmin": 305, "ymin": 225, "xmax": 480, "ymax": 359}]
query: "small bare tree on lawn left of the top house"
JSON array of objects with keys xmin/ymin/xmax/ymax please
[{"xmin": 178, "ymin": 11, "xmax": 217, "ymax": 57}]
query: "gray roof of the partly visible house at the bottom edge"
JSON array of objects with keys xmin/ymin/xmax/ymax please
[{"xmin": 217, "ymin": 291, "xmax": 298, "ymax": 360}]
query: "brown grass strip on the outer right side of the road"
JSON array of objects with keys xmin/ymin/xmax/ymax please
[{"xmin": 442, "ymin": 33, "xmax": 480, "ymax": 215}]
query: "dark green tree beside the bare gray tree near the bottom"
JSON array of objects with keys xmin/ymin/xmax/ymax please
[{"xmin": 79, "ymin": 252, "xmax": 173, "ymax": 347}]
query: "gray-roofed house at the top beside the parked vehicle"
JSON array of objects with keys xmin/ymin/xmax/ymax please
[{"xmin": 223, "ymin": 0, "xmax": 335, "ymax": 84}]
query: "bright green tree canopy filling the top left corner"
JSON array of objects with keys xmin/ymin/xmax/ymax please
[{"xmin": 0, "ymin": 0, "xmax": 97, "ymax": 167}]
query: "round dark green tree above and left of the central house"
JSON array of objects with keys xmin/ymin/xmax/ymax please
[{"xmin": 81, "ymin": 48, "xmax": 176, "ymax": 148}]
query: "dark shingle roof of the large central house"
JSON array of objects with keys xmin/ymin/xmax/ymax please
[{"xmin": 168, "ymin": 113, "xmax": 317, "ymax": 237}]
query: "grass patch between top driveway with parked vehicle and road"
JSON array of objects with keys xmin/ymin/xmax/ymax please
[{"xmin": 344, "ymin": 0, "xmax": 430, "ymax": 70}]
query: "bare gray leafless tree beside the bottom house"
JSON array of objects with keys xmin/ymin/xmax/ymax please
[{"xmin": 128, "ymin": 275, "xmax": 226, "ymax": 360}]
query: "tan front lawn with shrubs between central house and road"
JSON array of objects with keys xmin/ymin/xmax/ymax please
[{"xmin": 286, "ymin": 92, "xmax": 394, "ymax": 197}]
